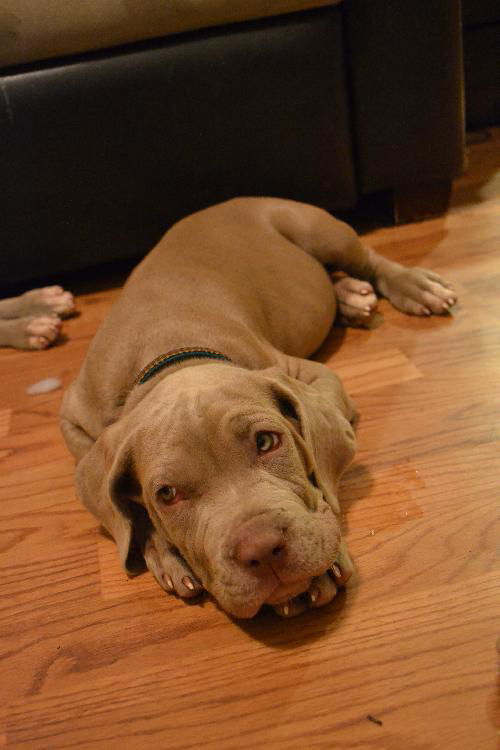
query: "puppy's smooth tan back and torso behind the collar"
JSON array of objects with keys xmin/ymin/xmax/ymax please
[{"xmin": 63, "ymin": 198, "xmax": 335, "ymax": 444}]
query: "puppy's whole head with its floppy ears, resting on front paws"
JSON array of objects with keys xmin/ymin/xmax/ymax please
[{"xmin": 81, "ymin": 364, "xmax": 355, "ymax": 617}]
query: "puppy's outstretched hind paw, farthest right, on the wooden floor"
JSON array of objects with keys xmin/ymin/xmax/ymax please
[{"xmin": 377, "ymin": 267, "xmax": 457, "ymax": 315}]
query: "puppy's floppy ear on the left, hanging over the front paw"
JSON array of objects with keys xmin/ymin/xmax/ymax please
[{"xmin": 76, "ymin": 422, "xmax": 152, "ymax": 575}]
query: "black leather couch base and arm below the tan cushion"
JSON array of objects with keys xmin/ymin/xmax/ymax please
[{"xmin": 0, "ymin": 0, "xmax": 464, "ymax": 286}]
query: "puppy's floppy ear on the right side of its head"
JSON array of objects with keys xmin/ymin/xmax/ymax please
[{"xmin": 268, "ymin": 362, "xmax": 357, "ymax": 512}]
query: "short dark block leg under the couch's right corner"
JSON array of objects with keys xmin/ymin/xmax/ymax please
[{"xmin": 392, "ymin": 180, "xmax": 452, "ymax": 224}]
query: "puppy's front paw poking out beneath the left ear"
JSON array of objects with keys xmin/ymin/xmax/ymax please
[{"xmin": 144, "ymin": 532, "xmax": 203, "ymax": 599}]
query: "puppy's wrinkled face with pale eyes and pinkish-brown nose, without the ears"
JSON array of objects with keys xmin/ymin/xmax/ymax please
[{"xmin": 134, "ymin": 366, "xmax": 354, "ymax": 617}]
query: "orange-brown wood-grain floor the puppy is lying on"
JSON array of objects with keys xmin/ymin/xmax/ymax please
[{"xmin": 0, "ymin": 130, "xmax": 500, "ymax": 750}]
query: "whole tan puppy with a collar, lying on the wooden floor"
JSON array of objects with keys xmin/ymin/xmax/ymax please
[{"xmin": 61, "ymin": 198, "xmax": 456, "ymax": 618}]
